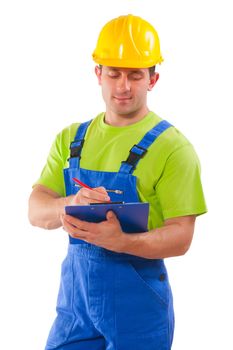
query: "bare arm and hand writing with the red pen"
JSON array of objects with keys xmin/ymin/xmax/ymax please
[{"xmin": 28, "ymin": 185, "xmax": 110, "ymax": 230}]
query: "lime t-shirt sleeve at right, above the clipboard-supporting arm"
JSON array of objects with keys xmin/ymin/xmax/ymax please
[{"xmin": 156, "ymin": 144, "xmax": 207, "ymax": 219}]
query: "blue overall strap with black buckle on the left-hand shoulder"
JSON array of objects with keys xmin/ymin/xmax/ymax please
[{"xmin": 68, "ymin": 119, "xmax": 92, "ymax": 168}]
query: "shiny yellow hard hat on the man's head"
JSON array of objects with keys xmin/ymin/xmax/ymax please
[{"xmin": 92, "ymin": 15, "xmax": 163, "ymax": 68}]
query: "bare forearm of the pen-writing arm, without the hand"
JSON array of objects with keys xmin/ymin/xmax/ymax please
[{"xmin": 28, "ymin": 192, "xmax": 70, "ymax": 229}]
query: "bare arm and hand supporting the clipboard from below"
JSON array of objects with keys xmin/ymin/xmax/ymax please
[{"xmin": 62, "ymin": 212, "xmax": 196, "ymax": 259}]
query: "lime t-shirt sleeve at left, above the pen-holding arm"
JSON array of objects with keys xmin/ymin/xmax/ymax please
[{"xmin": 33, "ymin": 132, "xmax": 68, "ymax": 197}]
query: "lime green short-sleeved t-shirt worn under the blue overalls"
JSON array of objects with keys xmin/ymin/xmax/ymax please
[{"xmin": 34, "ymin": 112, "xmax": 207, "ymax": 229}]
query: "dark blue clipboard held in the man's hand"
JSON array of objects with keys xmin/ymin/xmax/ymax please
[{"xmin": 65, "ymin": 202, "xmax": 149, "ymax": 233}]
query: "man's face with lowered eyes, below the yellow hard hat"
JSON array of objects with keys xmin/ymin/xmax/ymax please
[{"xmin": 95, "ymin": 66, "xmax": 158, "ymax": 117}]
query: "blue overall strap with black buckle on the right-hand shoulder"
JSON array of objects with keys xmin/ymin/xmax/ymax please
[{"xmin": 119, "ymin": 120, "xmax": 172, "ymax": 174}]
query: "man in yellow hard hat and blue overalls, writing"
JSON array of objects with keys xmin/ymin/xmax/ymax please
[{"xmin": 29, "ymin": 15, "xmax": 206, "ymax": 350}]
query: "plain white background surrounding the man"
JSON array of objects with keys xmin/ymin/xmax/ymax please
[{"xmin": 0, "ymin": 0, "xmax": 233, "ymax": 350}]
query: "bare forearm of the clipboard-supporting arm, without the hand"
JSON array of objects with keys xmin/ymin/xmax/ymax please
[{"xmin": 119, "ymin": 224, "xmax": 193, "ymax": 259}]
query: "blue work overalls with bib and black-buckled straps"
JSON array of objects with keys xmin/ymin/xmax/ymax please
[{"xmin": 46, "ymin": 120, "xmax": 174, "ymax": 350}]
